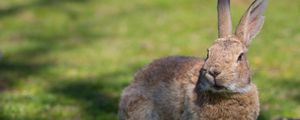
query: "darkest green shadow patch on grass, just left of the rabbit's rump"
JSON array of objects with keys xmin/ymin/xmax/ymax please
[{"xmin": 52, "ymin": 80, "xmax": 118, "ymax": 116}]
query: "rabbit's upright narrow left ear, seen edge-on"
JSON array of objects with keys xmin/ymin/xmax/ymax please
[{"xmin": 218, "ymin": 0, "xmax": 232, "ymax": 38}]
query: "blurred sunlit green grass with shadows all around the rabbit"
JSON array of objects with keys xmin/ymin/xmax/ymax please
[{"xmin": 0, "ymin": 0, "xmax": 300, "ymax": 120}]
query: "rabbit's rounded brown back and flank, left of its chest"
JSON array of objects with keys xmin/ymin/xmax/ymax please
[{"xmin": 119, "ymin": 56, "xmax": 204, "ymax": 120}]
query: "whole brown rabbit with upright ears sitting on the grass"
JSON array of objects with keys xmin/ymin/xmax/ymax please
[{"xmin": 118, "ymin": 0, "xmax": 267, "ymax": 120}]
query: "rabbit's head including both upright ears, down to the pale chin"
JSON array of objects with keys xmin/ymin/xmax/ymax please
[{"xmin": 198, "ymin": 0, "xmax": 267, "ymax": 93}]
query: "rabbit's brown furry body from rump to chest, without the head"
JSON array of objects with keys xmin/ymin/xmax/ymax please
[{"xmin": 119, "ymin": 56, "xmax": 259, "ymax": 120}]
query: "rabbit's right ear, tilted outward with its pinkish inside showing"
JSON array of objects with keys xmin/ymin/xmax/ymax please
[{"xmin": 235, "ymin": 0, "xmax": 267, "ymax": 46}]
